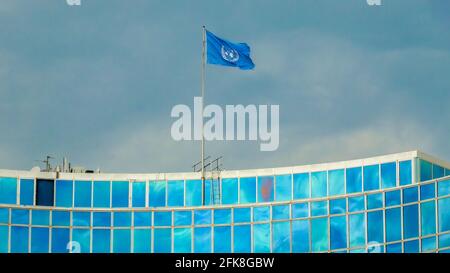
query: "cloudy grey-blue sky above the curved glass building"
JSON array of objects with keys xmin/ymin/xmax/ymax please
[{"xmin": 0, "ymin": 0, "xmax": 450, "ymax": 172}]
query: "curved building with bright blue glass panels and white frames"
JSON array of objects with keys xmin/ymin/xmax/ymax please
[{"xmin": 0, "ymin": 151, "xmax": 450, "ymax": 253}]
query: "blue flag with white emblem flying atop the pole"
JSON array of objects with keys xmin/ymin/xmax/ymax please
[{"xmin": 206, "ymin": 31, "xmax": 255, "ymax": 70}]
